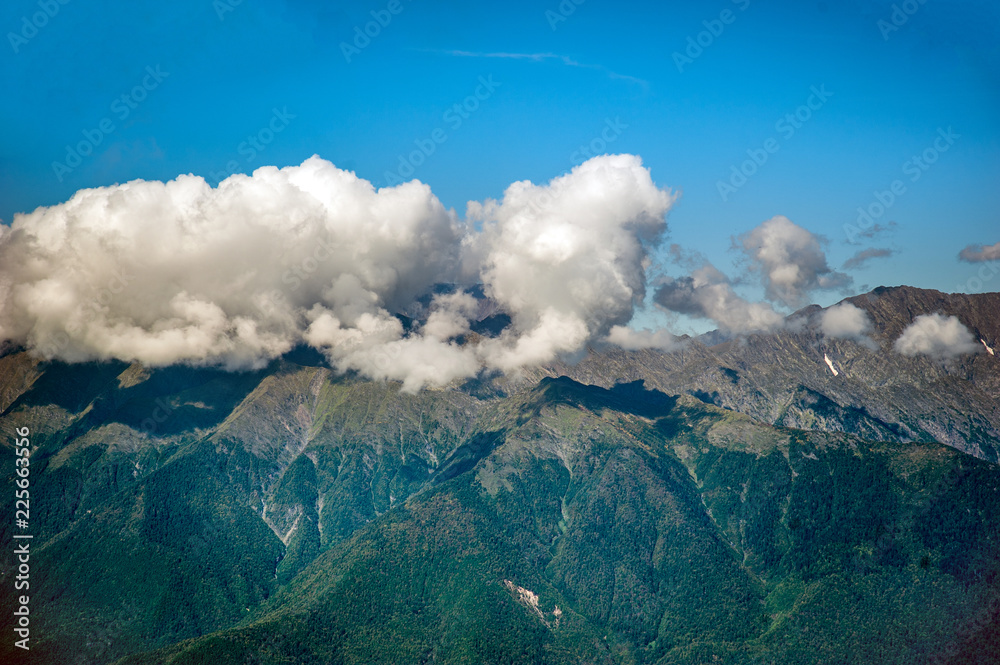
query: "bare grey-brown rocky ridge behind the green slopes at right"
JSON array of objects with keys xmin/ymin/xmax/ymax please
[{"xmin": 528, "ymin": 286, "xmax": 1000, "ymax": 462}]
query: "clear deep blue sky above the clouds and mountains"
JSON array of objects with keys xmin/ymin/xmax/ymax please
[{"xmin": 0, "ymin": 0, "xmax": 1000, "ymax": 326}]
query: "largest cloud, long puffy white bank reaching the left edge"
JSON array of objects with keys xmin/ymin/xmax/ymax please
[{"xmin": 0, "ymin": 157, "xmax": 461, "ymax": 368}]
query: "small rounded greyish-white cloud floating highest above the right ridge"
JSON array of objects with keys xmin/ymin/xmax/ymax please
[{"xmin": 738, "ymin": 215, "xmax": 851, "ymax": 307}]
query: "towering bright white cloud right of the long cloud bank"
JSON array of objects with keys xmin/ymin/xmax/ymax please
[{"xmin": 467, "ymin": 155, "xmax": 674, "ymax": 370}]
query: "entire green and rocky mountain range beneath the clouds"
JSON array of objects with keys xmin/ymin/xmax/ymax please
[{"xmin": 0, "ymin": 287, "xmax": 1000, "ymax": 665}]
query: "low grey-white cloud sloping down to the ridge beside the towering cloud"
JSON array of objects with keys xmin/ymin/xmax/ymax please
[{"xmin": 653, "ymin": 261, "xmax": 784, "ymax": 333}]
